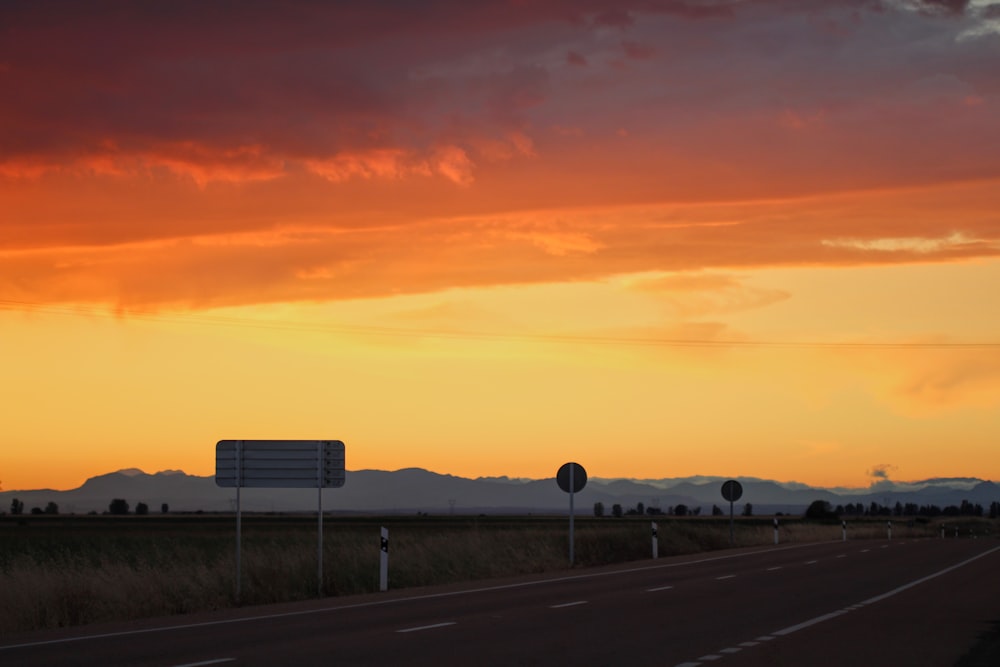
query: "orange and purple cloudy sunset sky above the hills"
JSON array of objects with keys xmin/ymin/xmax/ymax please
[{"xmin": 0, "ymin": 0, "xmax": 1000, "ymax": 490}]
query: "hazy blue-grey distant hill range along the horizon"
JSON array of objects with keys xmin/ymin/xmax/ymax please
[{"xmin": 0, "ymin": 468, "xmax": 1000, "ymax": 514}]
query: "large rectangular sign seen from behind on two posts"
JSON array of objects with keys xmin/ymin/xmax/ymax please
[{"xmin": 215, "ymin": 440, "xmax": 346, "ymax": 489}]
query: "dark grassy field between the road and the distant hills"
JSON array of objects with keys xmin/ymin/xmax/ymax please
[{"xmin": 0, "ymin": 515, "xmax": 998, "ymax": 635}]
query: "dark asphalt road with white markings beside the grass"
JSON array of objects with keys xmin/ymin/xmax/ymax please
[{"xmin": 0, "ymin": 539, "xmax": 1000, "ymax": 667}]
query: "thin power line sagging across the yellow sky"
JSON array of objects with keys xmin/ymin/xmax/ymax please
[{"xmin": 0, "ymin": 299, "xmax": 1000, "ymax": 350}]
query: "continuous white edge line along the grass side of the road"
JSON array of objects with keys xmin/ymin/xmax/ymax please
[{"xmin": 0, "ymin": 542, "xmax": 826, "ymax": 651}]
